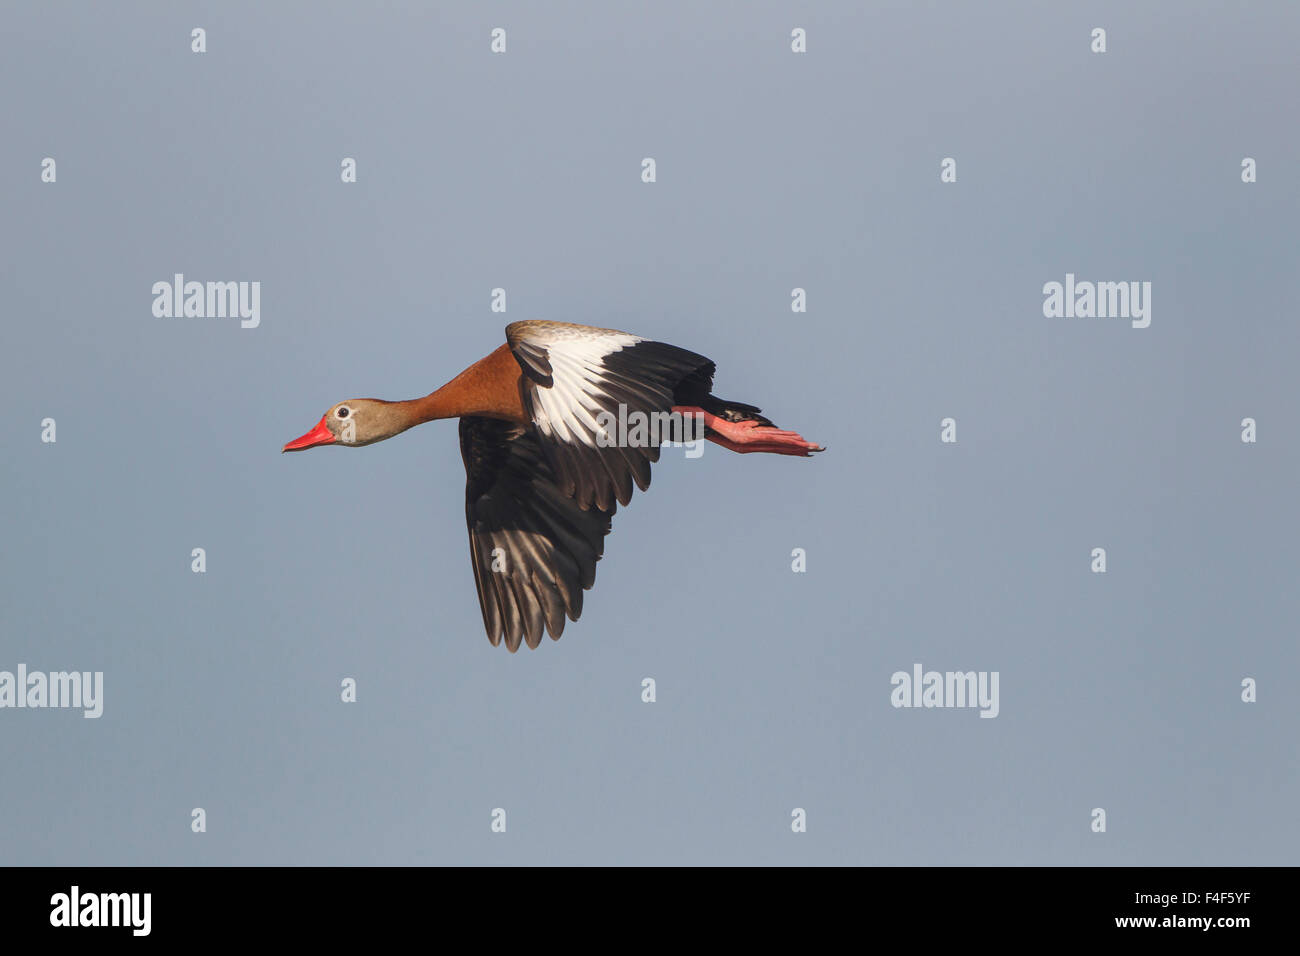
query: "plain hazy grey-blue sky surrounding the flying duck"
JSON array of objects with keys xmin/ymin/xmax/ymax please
[{"xmin": 0, "ymin": 3, "xmax": 1300, "ymax": 865}]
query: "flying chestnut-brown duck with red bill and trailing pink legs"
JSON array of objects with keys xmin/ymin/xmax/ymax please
[{"xmin": 282, "ymin": 321, "xmax": 823, "ymax": 652}]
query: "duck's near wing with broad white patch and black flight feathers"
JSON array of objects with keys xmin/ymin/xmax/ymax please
[{"xmin": 506, "ymin": 321, "xmax": 714, "ymax": 511}]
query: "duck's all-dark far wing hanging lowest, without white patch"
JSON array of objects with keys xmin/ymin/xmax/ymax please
[{"xmin": 460, "ymin": 416, "xmax": 615, "ymax": 652}]
